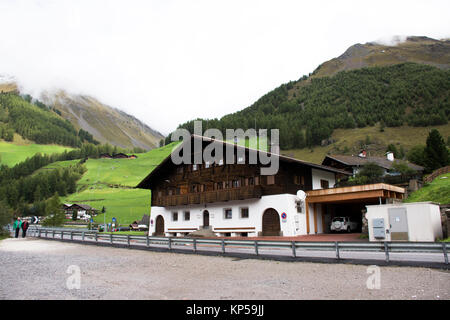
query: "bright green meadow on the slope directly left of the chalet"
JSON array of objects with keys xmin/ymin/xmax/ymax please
[{"xmin": 58, "ymin": 143, "xmax": 176, "ymax": 225}]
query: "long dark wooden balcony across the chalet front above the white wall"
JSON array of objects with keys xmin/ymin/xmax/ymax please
[{"xmin": 152, "ymin": 186, "xmax": 262, "ymax": 207}]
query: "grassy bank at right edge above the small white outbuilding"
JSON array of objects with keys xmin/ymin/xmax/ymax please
[{"xmin": 405, "ymin": 173, "xmax": 450, "ymax": 204}]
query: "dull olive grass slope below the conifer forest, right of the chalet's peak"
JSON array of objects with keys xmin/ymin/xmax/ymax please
[{"xmin": 281, "ymin": 124, "xmax": 450, "ymax": 164}]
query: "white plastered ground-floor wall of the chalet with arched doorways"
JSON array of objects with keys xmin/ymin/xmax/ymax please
[{"xmin": 150, "ymin": 194, "xmax": 314, "ymax": 237}]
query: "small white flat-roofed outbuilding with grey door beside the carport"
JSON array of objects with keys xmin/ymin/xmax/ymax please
[{"xmin": 366, "ymin": 202, "xmax": 442, "ymax": 242}]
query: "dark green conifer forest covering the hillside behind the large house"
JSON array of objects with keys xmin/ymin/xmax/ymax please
[{"xmin": 171, "ymin": 63, "xmax": 450, "ymax": 149}]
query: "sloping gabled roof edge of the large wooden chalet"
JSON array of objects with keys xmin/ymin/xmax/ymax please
[{"xmin": 136, "ymin": 134, "xmax": 351, "ymax": 188}]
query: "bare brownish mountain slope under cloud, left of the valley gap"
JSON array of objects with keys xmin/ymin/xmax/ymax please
[{"xmin": 41, "ymin": 90, "xmax": 164, "ymax": 150}]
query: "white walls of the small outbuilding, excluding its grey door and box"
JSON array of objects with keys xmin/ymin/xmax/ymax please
[{"xmin": 367, "ymin": 202, "xmax": 442, "ymax": 241}]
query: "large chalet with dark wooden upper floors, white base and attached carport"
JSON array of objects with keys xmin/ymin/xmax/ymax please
[{"xmin": 137, "ymin": 136, "xmax": 403, "ymax": 237}]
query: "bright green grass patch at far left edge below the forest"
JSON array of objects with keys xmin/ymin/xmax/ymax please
[{"xmin": 0, "ymin": 141, "xmax": 73, "ymax": 167}]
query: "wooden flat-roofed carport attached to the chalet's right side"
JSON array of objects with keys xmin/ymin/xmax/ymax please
[{"xmin": 305, "ymin": 183, "xmax": 405, "ymax": 234}]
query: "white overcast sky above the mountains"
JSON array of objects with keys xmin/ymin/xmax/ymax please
[{"xmin": 0, "ymin": 0, "xmax": 450, "ymax": 134}]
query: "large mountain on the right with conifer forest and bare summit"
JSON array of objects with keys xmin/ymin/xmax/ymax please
[{"xmin": 172, "ymin": 37, "xmax": 450, "ymax": 150}]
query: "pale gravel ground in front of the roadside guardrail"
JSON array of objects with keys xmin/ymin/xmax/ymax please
[{"xmin": 0, "ymin": 238, "xmax": 450, "ymax": 300}]
